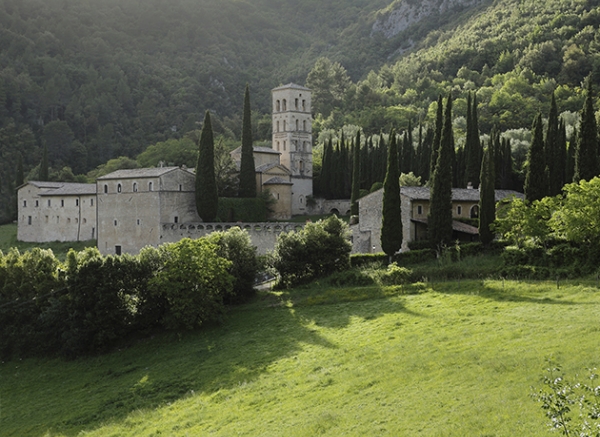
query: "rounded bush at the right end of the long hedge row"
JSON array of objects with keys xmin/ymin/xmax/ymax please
[{"xmin": 206, "ymin": 227, "xmax": 259, "ymax": 303}]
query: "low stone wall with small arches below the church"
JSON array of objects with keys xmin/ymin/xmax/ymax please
[{"xmin": 160, "ymin": 222, "xmax": 303, "ymax": 255}]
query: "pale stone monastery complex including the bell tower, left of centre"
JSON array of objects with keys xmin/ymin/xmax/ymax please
[{"xmin": 17, "ymin": 84, "xmax": 313, "ymax": 255}]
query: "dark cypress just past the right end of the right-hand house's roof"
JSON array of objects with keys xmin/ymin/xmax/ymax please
[{"xmin": 524, "ymin": 113, "xmax": 548, "ymax": 202}]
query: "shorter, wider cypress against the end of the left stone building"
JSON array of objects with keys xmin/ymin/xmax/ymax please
[{"xmin": 196, "ymin": 111, "xmax": 219, "ymax": 222}]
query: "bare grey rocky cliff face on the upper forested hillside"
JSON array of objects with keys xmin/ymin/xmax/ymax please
[{"xmin": 373, "ymin": 0, "xmax": 483, "ymax": 38}]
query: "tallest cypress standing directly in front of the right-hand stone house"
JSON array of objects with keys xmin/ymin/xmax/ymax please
[{"xmin": 427, "ymin": 94, "xmax": 454, "ymax": 251}]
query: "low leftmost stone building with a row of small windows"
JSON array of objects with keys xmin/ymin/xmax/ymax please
[{"xmin": 17, "ymin": 181, "xmax": 97, "ymax": 243}]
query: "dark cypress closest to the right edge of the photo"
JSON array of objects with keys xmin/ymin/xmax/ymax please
[{"xmin": 573, "ymin": 77, "xmax": 600, "ymax": 182}]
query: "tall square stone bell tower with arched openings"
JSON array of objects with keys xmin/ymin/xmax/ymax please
[{"xmin": 271, "ymin": 83, "xmax": 313, "ymax": 215}]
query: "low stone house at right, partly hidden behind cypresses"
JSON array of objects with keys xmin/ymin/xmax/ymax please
[{"xmin": 351, "ymin": 187, "xmax": 524, "ymax": 253}]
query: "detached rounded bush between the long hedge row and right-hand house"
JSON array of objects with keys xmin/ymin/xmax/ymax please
[{"xmin": 273, "ymin": 216, "xmax": 352, "ymax": 287}]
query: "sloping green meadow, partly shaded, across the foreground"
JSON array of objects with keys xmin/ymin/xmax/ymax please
[{"xmin": 0, "ymin": 281, "xmax": 600, "ymax": 436}]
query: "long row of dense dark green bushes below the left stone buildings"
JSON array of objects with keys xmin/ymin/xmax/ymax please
[{"xmin": 0, "ymin": 228, "xmax": 258, "ymax": 358}]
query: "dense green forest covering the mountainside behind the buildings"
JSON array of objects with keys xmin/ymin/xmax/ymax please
[{"xmin": 0, "ymin": 0, "xmax": 600, "ymax": 222}]
